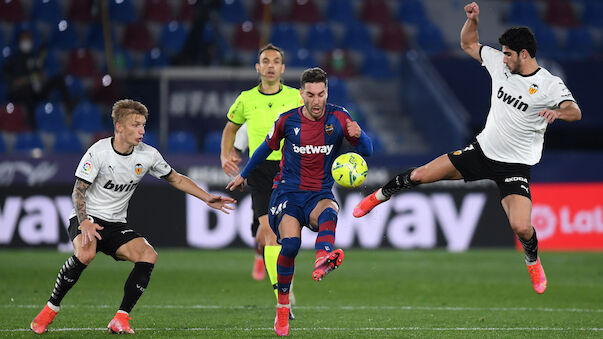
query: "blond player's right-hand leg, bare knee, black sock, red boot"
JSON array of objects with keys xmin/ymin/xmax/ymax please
[{"xmin": 107, "ymin": 238, "xmax": 157, "ymax": 334}]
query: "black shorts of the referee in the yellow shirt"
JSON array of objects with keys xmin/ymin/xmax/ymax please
[{"xmin": 247, "ymin": 160, "xmax": 281, "ymax": 237}]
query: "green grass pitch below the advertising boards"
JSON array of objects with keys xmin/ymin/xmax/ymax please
[{"xmin": 0, "ymin": 249, "xmax": 603, "ymax": 338}]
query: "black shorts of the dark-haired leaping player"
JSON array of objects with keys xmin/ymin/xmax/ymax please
[{"xmin": 448, "ymin": 141, "xmax": 532, "ymax": 200}]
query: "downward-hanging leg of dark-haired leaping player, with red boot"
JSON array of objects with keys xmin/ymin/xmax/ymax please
[{"xmin": 501, "ymin": 194, "xmax": 548, "ymax": 294}]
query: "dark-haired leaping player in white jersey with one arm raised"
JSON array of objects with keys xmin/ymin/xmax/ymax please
[{"xmin": 353, "ymin": 2, "xmax": 582, "ymax": 293}]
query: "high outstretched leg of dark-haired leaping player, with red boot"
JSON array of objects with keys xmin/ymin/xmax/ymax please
[{"xmin": 353, "ymin": 154, "xmax": 462, "ymax": 218}]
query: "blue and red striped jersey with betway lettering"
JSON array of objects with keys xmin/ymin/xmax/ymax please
[{"xmin": 266, "ymin": 104, "xmax": 358, "ymax": 191}]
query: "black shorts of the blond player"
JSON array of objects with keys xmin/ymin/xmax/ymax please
[{"xmin": 68, "ymin": 217, "xmax": 142, "ymax": 260}]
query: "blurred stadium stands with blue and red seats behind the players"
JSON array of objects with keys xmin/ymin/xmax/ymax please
[{"xmin": 0, "ymin": 0, "xmax": 603, "ymax": 155}]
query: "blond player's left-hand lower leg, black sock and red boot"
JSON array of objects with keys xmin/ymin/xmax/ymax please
[{"xmin": 29, "ymin": 234, "xmax": 96, "ymax": 334}]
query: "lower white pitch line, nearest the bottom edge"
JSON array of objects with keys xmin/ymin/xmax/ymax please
[{"xmin": 0, "ymin": 327, "xmax": 603, "ymax": 333}]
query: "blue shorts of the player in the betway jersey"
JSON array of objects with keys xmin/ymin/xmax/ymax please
[{"xmin": 268, "ymin": 188, "xmax": 337, "ymax": 243}]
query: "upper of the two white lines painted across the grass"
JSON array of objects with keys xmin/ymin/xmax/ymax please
[{"xmin": 0, "ymin": 304, "xmax": 603, "ymax": 313}]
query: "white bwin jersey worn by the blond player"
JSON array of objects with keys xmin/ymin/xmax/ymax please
[{"xmin": 69, "ymin": 138, "xmax": 172, "ymax": 222}]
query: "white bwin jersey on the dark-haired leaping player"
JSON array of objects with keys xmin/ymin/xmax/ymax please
[{"xmin": 477, "ymin": 46, "xmax": 575, "ymax": 165}]
